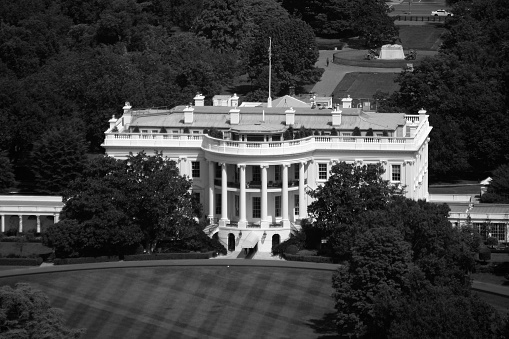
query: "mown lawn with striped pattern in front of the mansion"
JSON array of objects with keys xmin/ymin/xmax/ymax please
[{"xmin": 0, "ymin": 266, "xmax": 334, "ymax": 338}]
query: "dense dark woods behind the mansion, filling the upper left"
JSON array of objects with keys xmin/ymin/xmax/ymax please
[{"xmin": 0, "ymin": 0, "xmax": 319, "ymax": 193}]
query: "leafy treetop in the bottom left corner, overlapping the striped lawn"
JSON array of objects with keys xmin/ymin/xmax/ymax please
[{"xmin": 0, "ymin": 283, "xmax": 84, "ymax": 339}]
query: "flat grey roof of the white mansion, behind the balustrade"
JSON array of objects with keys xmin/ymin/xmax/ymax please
[{"xmin": 131, "ymin": 106, "xmax": 405, "ymax": 132}]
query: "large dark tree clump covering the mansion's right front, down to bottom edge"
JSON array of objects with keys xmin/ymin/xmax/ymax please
[{"xmin": 302, "ymin": 163, "xmax": 504, "ymax": 338}]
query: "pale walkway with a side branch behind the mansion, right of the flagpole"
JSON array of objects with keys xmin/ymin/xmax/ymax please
[{"xmin": 311, "ymin": 50, "xmax": 401, "ymax": 96}]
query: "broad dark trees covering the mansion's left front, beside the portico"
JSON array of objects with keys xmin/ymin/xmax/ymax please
[{"xmin": 44, "ymin": 152, "xmax": 224, "ymax": 257}]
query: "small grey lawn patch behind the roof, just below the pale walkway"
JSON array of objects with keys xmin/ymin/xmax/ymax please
[{"xmin": 333, "ymin": 72, "xmax": 399, "ymax": 98}]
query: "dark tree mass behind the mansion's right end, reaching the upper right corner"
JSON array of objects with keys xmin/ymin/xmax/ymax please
[{"xmin": 379, "ymin": 0, "xmax": 509, "ymax": 180}]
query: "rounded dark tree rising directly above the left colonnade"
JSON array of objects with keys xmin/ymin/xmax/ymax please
[{"xmin": 32, "ymin": 121, "xmax": 87, "ymax": 194}]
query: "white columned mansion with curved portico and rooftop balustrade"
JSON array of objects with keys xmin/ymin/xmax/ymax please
[{"xmin": 103, "ymin": 94, "xmax": 431, "ymax": 252}]
